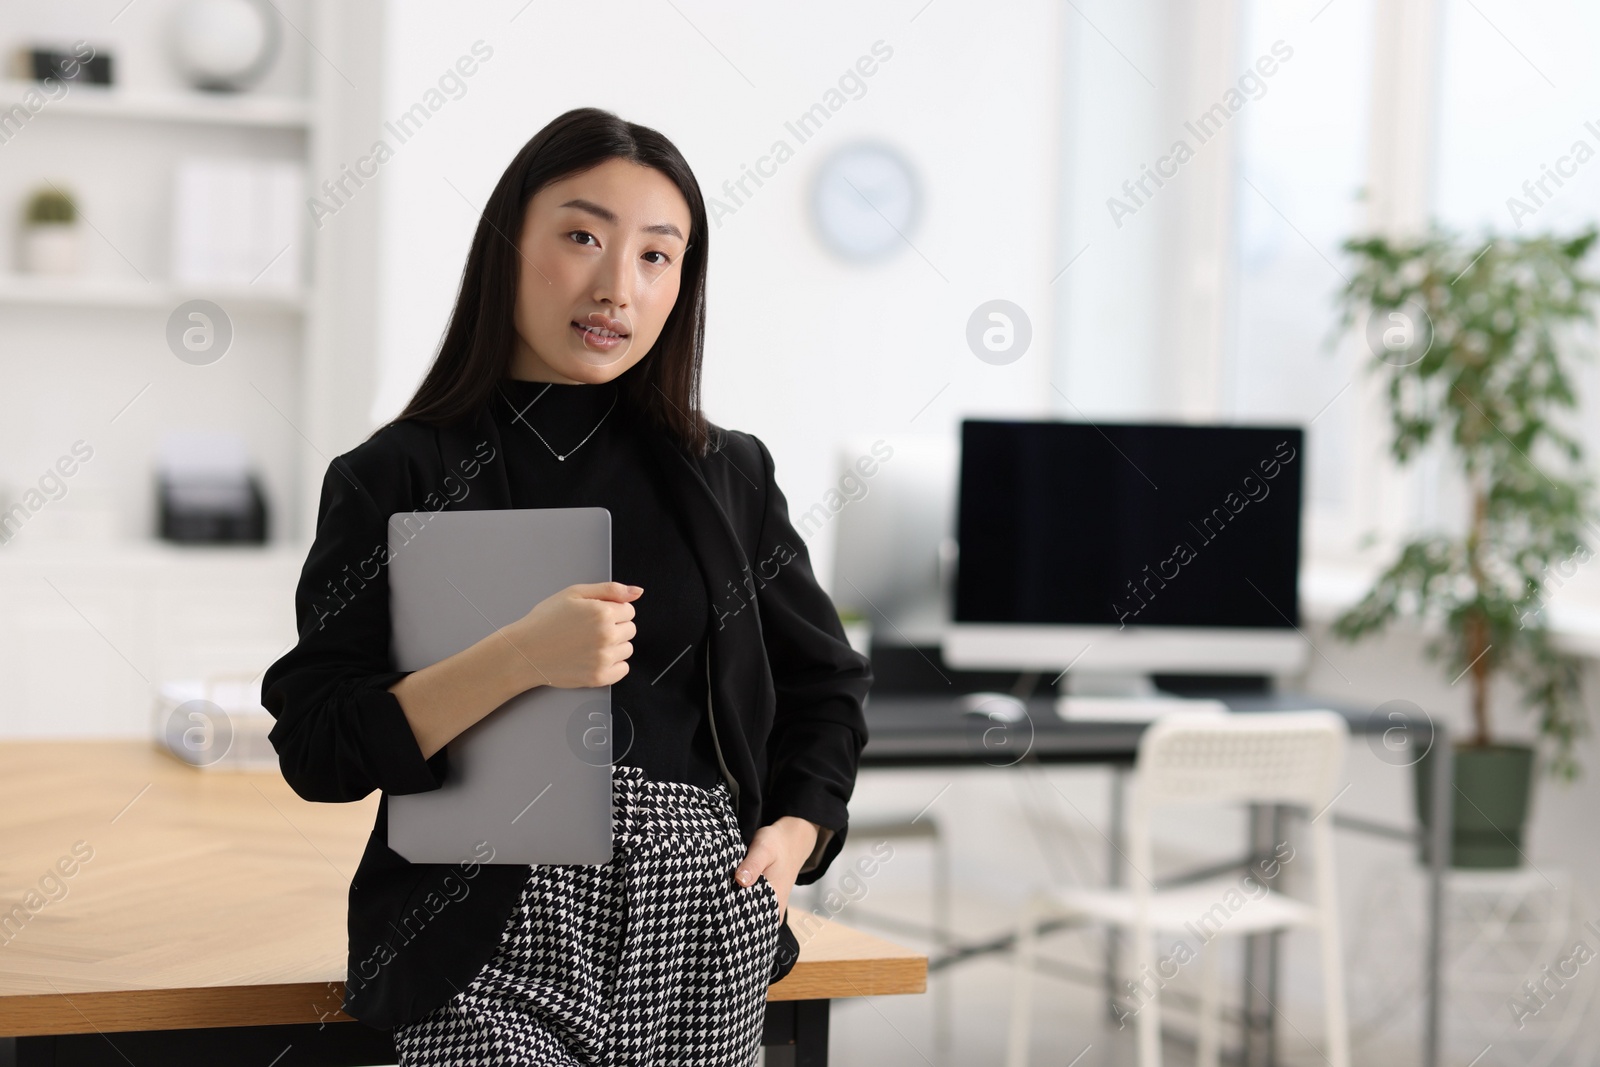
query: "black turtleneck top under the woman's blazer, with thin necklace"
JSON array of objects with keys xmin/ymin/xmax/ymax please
[{"xmin": 491, "ymin": 378, "xmax": 722, "ymax": 789}]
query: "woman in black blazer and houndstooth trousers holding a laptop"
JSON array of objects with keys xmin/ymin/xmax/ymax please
[{"xmin": 262, "ymin": 109, "xmax": 872, "ymax": 1065}]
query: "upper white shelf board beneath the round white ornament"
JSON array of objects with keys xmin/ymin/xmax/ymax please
[{"xmin": 0, "ymin": 80, "xmax": 312, "ymax": 130}]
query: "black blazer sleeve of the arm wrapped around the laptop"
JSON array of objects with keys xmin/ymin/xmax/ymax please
[{"xmin": 261, "ymin": 456, "xmax": 446, "ymax": 801}]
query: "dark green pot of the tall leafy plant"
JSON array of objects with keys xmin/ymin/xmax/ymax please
[{"xmin": 1416, "ymin": 745, "xmax": 1533, "ymax": 870}]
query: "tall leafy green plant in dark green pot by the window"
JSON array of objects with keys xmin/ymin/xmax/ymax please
[{"xmin": 1333, "ymin": 227, "xmax": 1600, "ymax": 867}]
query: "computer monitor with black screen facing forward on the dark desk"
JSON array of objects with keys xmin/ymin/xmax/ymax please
[{"xmin": 942, "ymin": 419, "xmax": 1307, "ymax": 678}]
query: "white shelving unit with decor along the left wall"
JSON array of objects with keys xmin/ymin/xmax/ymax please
[{"xmin": 0, "ymin": 0, "xmax": 382, "ymax": 737}]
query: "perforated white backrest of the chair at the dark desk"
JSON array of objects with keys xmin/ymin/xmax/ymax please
[{"xmin": 1134, "ymin": 712, "xmax": 1350, "ymax": 814}]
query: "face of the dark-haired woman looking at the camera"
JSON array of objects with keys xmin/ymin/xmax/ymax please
[{"xmin": 510, "ymin": 158, "xmax": 691, "ymax": 386}]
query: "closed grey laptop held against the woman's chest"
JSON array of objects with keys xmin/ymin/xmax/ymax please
[{"xmin": 389, "ymin": 507, "xmax": 611, "ymax": 864}]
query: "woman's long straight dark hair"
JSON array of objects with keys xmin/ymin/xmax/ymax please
[{"xmin": 373, "ymin": 107, "xmax": 707, "ymax": 456}]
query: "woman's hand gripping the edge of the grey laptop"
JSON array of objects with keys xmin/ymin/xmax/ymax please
[{"xmin": 502, "ymin": 582, "xmax": 645, "ymax": 689}]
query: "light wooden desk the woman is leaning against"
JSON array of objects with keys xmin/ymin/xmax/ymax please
[{"xmin": 0, "ymin": 741, "xmax": 928, "ymax": 1067}]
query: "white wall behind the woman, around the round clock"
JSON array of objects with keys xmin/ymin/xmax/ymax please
[{"xmin": 361, "ymin": 0, "xmax": 1064, "ymax": 591}]
